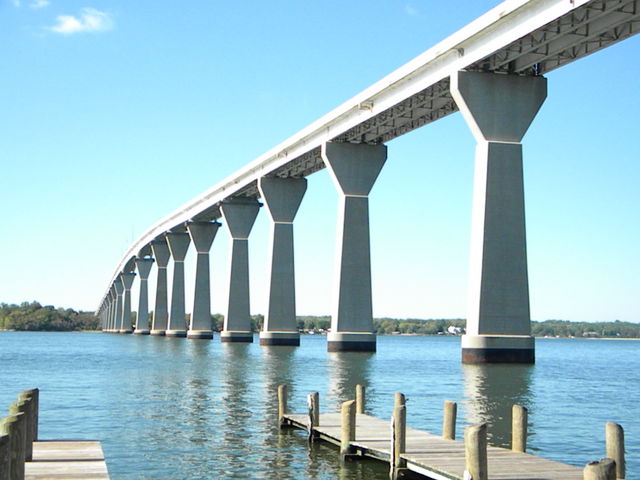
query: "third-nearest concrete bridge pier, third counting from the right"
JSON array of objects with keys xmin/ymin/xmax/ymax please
[{"xmin": 258, "ymin": 177, "xmax": 307, "ymax": 346}]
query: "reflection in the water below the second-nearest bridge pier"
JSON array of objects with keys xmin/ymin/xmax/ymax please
[{"xmin": 328, "ymin": 352, "xmax": 375, "ymax": 410}]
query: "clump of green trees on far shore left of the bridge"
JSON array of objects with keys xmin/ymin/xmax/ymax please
[{"xmin": 0, "ymin": 302, "xmax": 99, "ymax": 331}]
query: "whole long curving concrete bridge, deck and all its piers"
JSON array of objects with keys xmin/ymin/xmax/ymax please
[{"xmin": 96, "ymin": 0, "xmax": 640, "ymax": 363}]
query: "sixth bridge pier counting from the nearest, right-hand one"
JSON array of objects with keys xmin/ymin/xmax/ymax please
[{"xmin": 165, "ymin": 232, "xmax": 191, "ymax": 337}]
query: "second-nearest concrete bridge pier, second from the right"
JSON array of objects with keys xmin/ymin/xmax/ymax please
[{"xmin": 322, "ymin": 143, "xmax": 387, "ymax": 352}]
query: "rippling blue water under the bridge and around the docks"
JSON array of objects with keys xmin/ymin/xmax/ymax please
[{"xmin": 0, "ymin": 332, "xmax": 640, "ymax": 480}]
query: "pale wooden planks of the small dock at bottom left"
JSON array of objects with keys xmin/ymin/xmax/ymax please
[{"xmin": 25, "ymin": 440, "xmax": 109, "ymax": 480}]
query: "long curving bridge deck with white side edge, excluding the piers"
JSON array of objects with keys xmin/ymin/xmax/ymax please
[{"xmin": 96, "ymin": 0, "xmax": 640, "ymax": 314}]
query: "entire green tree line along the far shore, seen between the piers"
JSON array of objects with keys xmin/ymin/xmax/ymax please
[{"xmin": 0, "ymin": 302, "xmax": 640, "ymax": 338}]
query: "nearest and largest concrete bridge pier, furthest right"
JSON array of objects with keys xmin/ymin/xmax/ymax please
[{"xmin": 451, "ymin": 71, "xmax": 547, "ymax": 363}]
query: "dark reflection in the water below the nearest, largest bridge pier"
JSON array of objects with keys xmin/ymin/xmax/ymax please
[{"xmin": 462, "ymin": 364, "xmax": 535, "ymax": 447}]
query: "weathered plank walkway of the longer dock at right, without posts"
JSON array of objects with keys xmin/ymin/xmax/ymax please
[{"xmin": 285, "ymin": 413, "xmax": 583, "ymax": 480}]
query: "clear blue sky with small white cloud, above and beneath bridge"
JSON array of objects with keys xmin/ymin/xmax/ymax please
[{"xmin": 0, "ymin": 0, "xmax": 640, "ymax": 322}]
